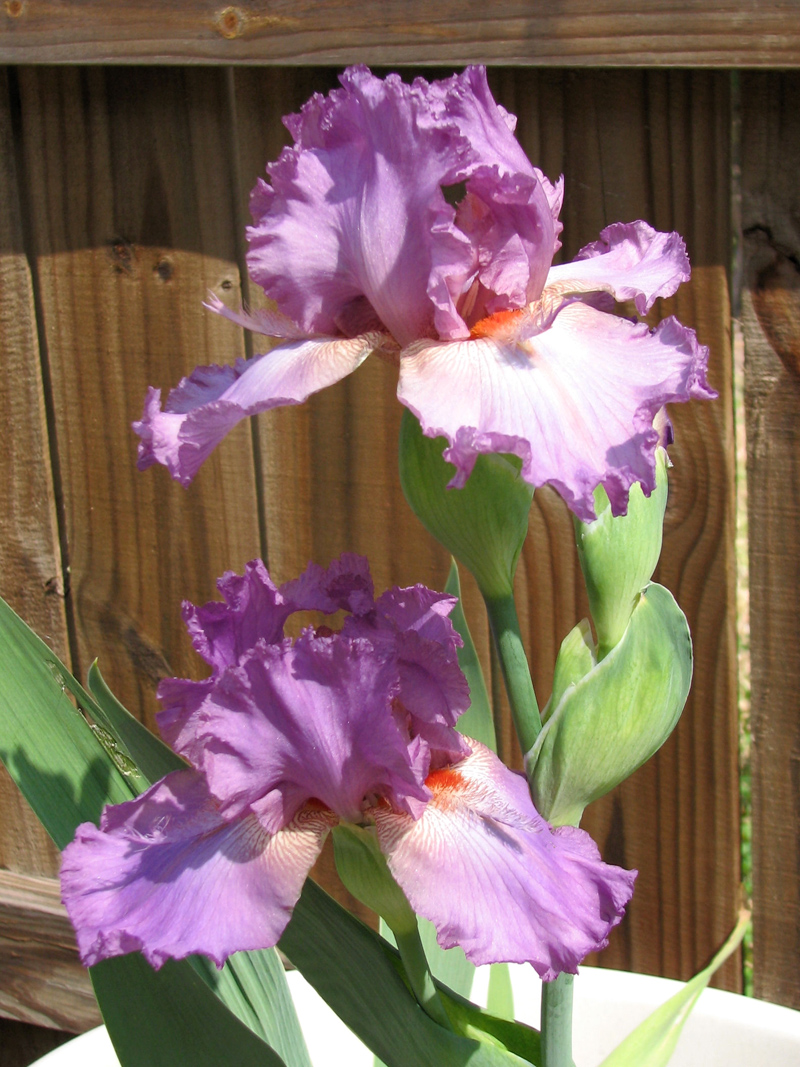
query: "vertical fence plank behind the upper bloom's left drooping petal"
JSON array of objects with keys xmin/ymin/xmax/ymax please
[{"xmin": 14, "ymin": 68, "xmax": 259, "ymax": 723}]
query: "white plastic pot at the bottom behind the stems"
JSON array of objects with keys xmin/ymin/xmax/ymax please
[{"xmin": 28, "ymin": 967, "xmax": 800, "ymax": 1067}]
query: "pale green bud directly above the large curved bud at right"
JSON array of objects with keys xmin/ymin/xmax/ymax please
[{"xmin": 575, "ymin": 448, "xmax": 669, "ymax": 659}]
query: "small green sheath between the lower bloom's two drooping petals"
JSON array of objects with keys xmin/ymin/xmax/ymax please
[{"xmin": 333, "ymin": 823, "xmax": 417, "ymax": 935}]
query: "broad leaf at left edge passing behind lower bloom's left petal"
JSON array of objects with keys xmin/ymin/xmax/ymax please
[{"xmin": 0, "ymin": 601, "xmax": 300, "ymax": 1067}]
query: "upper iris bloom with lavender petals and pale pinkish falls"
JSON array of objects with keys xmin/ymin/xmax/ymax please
[{"xmin": 134, "ymin": 67, "xmax": 715, "ymax": 521}]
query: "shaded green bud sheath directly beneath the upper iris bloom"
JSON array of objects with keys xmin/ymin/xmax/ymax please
[{"xmin": 400, "ymin": 410, "xmax": 533, "ymax": 599}]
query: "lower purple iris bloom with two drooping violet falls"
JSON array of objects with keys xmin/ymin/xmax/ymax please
[{"xmin": 61, "ymin": 556, "xmax": 636, "ymax": 978}]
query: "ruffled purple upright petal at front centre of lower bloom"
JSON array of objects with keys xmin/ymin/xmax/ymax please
[{"xmin": 176, "ymin": 631, "xmax": 429, "ymax": 829}]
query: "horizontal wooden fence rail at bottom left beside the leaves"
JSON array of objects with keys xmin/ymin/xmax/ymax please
[{"xmin": 0, "ymin": 871, "xmax": 101, "ymax": 1032}]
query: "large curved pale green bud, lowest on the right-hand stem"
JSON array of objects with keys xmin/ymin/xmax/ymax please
[{"xmin": 525, "ymin": 585, "xmax": 692, "ymax": 826}]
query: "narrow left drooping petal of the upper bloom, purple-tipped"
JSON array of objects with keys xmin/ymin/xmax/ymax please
[{"xmin": 133, "ymin": 333, "xmax": 385, "ymax": 485}]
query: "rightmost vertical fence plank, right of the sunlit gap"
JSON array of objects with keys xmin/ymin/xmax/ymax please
[{"xmin": 741, "ymin": 74, "xmax": 800, "ymax": 1008}]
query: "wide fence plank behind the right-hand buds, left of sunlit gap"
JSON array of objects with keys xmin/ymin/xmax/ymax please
[{"xmin": 491, "ymin": 70, "xmax": 741, "ymax": 989}]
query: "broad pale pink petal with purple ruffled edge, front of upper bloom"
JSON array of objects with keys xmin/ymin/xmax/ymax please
[{"xmin": 398, "ymin": 302, "xmax": 716, "ymax": 522}]
